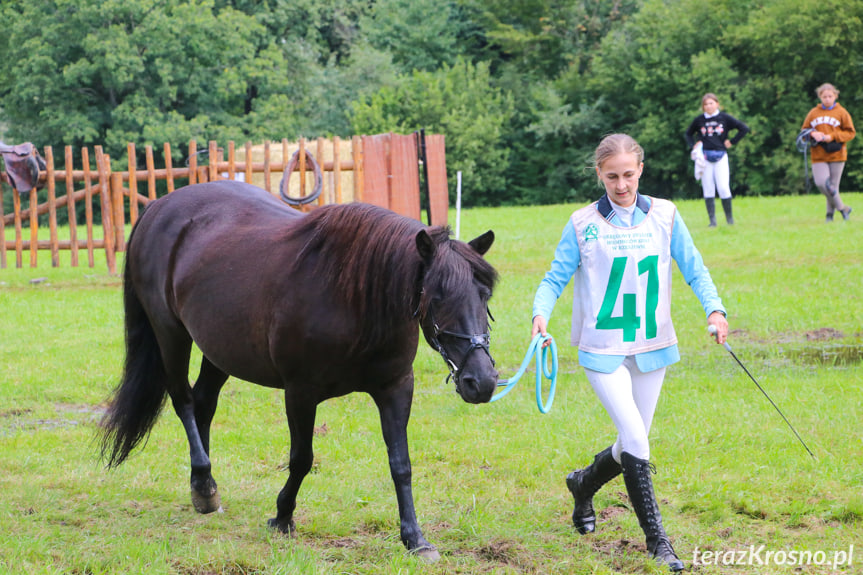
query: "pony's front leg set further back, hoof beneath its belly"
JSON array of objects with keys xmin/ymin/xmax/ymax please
[{"xmin": 267, "ymin": 391, "xmax": 317, "ymax": 535}]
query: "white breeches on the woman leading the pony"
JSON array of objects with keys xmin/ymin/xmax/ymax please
[{"xmin": 584, "ymin": 356, "xmax": 665, "ymax": 463}]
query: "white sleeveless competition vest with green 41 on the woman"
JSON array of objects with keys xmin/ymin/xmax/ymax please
[{"xmin": 571, "ymin": 198, "xmax": 677, "ymax": 355}]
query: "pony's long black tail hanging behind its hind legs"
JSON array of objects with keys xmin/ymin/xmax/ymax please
[{"xmin": 100, "ymin": 240, "xmax": 167, "ymax": 468}]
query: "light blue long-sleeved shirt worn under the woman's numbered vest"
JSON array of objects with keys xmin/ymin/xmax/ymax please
[{"xmin": 532, "ymin": 194, "xmax": 725, "ymax": 373}]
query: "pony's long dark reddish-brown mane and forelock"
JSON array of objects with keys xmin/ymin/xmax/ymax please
[{"xmin": 290, "ymin": 203, "xmax": 497, "ymax": 356}]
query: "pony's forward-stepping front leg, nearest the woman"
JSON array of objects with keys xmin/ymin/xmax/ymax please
[{"xmin": 372, "ymin": 374, "xmax": 440, "ymax": 562}]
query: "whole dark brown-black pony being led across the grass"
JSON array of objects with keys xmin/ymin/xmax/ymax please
[{"xmin": 101, "ymin": 181, "xmax": 498, "ymax": 560}]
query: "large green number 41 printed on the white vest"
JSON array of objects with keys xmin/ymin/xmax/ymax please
[{"xmin": 596, "ymin": 256, "xmax": 659, "ymax": 341}]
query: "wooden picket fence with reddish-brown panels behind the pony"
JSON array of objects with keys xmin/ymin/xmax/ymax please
[{"xmin": 0, "ymin": 132, "xmax": 449, "ymax": 273}]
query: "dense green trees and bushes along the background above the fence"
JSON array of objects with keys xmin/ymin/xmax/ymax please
[{"xmin": 0, "ymin": 0, "xmax": 863, "ymax": 205}]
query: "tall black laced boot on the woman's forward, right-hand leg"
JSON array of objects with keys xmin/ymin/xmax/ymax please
[{"xmin": 620, "ymin": 451, "xmax": 683, "ymax": 571}]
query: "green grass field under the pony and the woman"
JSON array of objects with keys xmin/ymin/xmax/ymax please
[{"xmin": 0, "ymin": 194, "xmax": 863, "ymax": 575}]
